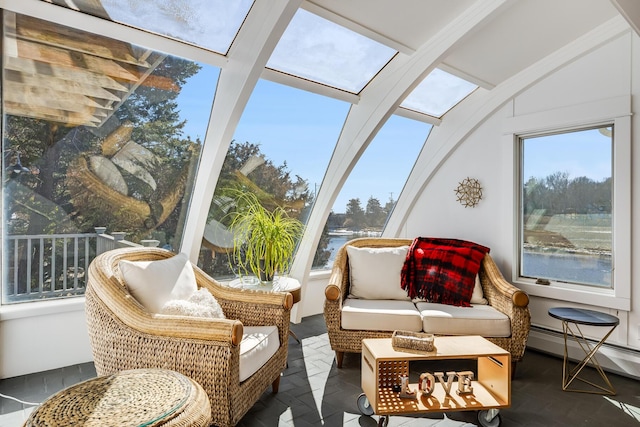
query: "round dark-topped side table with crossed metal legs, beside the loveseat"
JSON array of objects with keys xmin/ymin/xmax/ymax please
[{"xmin": 549, "ymin": 307, "xmax": 620, "ymax": 395}]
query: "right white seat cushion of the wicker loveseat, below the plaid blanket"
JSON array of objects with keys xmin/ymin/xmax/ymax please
[{"xmin": 416, "ymin": 302, "xmax": 511, "ymax": 338}]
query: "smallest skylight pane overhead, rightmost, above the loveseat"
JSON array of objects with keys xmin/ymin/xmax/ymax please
[{"xmin": 400, "ymin": 68, "xmax": 478, "ymax": 118}]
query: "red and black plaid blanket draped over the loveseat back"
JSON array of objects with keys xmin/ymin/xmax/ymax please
[{"xmin": 400, "ymin": 237, "xmax": 489, "ymax": 307}]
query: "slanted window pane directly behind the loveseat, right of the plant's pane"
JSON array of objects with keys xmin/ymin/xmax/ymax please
[{"xmin": 314, "ymin": 115, "xmax": 431, "ymax": 268}]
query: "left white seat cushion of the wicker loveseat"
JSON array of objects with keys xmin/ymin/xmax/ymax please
[{"xmin": 341, "ymin": 298, "xmax": 422, "ymax": 332}]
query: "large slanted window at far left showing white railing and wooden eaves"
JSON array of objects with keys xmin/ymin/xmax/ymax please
[{"xmin": 2, "ymin": 11, "xmax": 218, "ymax": 303}]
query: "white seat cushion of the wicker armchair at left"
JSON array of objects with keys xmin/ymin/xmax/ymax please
[{"xmin": 240, "ymin": 325, "xmax": 280, "ymax": 382}]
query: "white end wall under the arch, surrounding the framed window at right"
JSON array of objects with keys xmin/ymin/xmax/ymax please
[{"xmin": 403, "ymin": 33, "xmax": 640, "ymax": 377}]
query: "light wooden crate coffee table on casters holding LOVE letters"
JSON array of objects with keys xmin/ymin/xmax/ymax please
[{"xmin": 358, "ymin": 336, "xmax": 511, "ymax": 426}]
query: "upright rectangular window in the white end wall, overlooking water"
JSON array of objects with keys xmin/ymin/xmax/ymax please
[{"xmin": 519, "ymin": 125, "xmax": 613, "ymax": 288}]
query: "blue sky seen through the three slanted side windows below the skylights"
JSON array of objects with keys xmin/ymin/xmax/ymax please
[{"xmin": 178, "ymin": 66, "xmax": 430, "ymax": 212}]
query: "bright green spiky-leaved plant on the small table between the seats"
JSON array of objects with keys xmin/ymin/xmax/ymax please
[{"xmin": 229, "ymin": 192, "xmax": 304, "ymax": 282}]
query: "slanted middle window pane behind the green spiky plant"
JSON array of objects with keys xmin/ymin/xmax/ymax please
[{"xmin": 198, "ymin": 80, "xmax": 350, "ymax": 279}]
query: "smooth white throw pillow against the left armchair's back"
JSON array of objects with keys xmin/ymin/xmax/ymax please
[{"xmin": 118, "ymin": 253, "xmax": 198, "ymax": 313}]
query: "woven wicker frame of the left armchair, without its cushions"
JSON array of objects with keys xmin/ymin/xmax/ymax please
[{"xmin": 86, "ymin": 248, "xmax": 292, "ymax": 426}]
